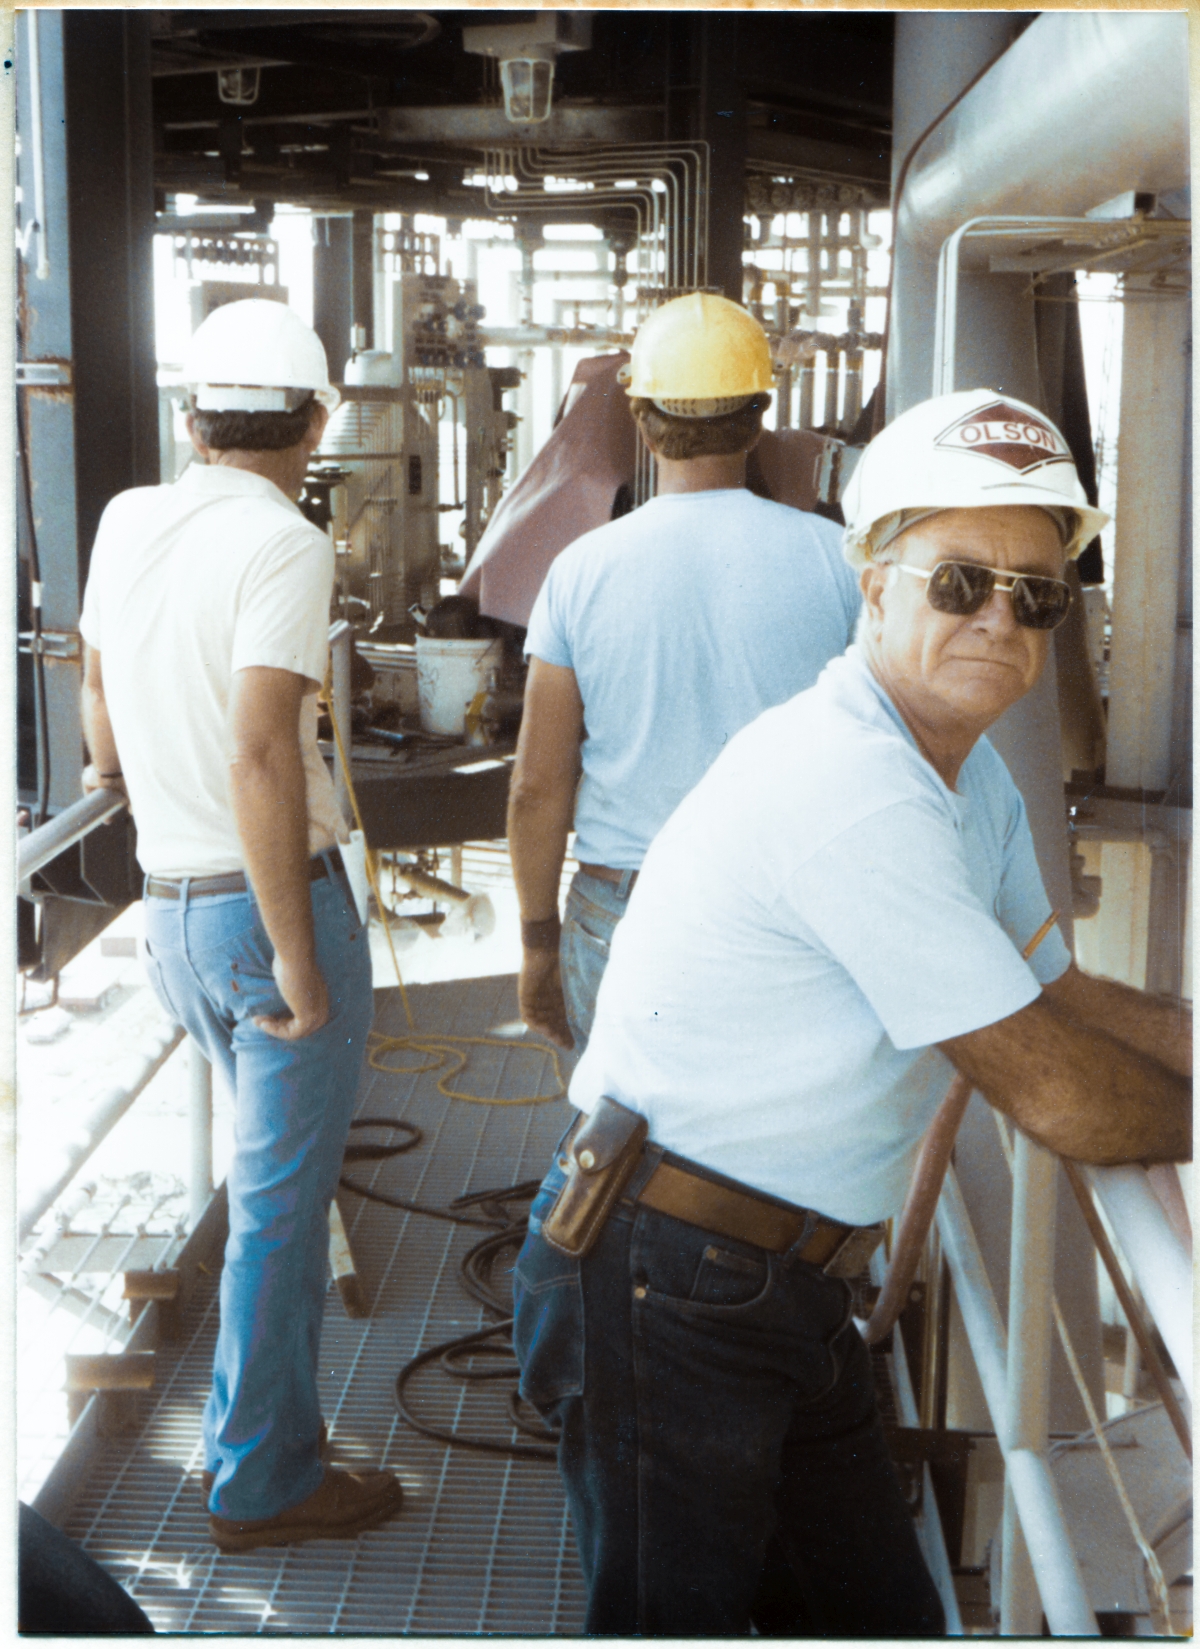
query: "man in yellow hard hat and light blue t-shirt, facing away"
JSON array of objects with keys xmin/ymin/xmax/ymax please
[{"xmin": 508, "ymin": 292, "xmax": 859, "ymax": 1050}]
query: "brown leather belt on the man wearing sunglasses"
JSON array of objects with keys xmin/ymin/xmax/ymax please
[{"xmin": 633, "ymin": 1163, "xmax": 884, "ymax": 1276}]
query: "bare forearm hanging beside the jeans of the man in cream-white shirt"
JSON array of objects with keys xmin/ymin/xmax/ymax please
[{"xmin": 229, "ymin": 740, "xmax": 316, "ymax": 966}]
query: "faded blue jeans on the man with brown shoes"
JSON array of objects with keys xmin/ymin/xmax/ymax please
[{"xmin": 145, "ymin": 853, "xmax": 373, "ymax": 1519}]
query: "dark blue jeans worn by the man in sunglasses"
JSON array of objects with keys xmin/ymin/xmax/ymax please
[{"xmin": 513, "ymin": 1151, "xmax": 945, "ymax": 1637}]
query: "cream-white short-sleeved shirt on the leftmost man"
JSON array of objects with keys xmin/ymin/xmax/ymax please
[{"xmin": 79, "ymin": 465, "xmax": 345, "ymax": 876}]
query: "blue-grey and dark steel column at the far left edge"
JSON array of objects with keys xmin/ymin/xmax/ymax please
[{"xmin": 16, "ymin": 8, "xmax": 158, "ymax": 811}]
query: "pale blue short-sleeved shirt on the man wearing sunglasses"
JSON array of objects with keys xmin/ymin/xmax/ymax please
[{"xmin": 570, "ymin": 646, "xmax": 1070, "ymax": 1224}]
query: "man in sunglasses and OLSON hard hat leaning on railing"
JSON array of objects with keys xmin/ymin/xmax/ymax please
[{"xmin": 514, "ymin": 391, "xmax": 1192, "ymax": 1637}]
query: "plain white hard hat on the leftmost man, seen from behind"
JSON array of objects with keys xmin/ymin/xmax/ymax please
[{"xmin": 183, "ymin": 298, "xmax": 341, "ymax": 412}]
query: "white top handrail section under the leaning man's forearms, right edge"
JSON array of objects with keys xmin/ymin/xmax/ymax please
[{"xmin": 1083, "ymin": 1163, "xmax": 1192, "ymax": 1402}]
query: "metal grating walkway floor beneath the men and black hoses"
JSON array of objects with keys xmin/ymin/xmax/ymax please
[{"xmin": 66, "ymin": 976, "xmax": 584, "ymax": 1636}]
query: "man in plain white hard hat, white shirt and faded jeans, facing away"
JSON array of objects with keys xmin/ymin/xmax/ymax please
[{"xmin": 79, "ymin": 298, "xmax": 401, "ymax": 1552}]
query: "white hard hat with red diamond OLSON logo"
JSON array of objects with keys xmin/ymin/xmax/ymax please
[{"xmin": 841, "ymin": 389, "xmax": 1109, "ymax": 567}]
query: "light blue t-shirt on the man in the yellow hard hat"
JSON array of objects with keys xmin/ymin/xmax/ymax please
[{"xmin": 526, "ymin": 488, "xmax": 859, "ymax": 871}]
